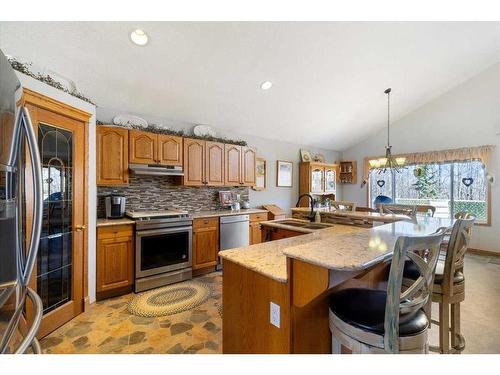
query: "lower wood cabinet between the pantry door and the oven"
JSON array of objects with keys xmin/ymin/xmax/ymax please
[{"xmin": 96, "ymin": 225, "xmax": 134, "ymax": 299}]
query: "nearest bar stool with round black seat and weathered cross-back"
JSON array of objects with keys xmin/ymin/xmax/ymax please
[{"xmin": 329, "ymin": 229, "xmax": 445, "ymax": 354}]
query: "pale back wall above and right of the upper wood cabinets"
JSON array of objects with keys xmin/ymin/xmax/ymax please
[{"xmin": 97, "ymin": 108, "xmax": 342, "ymax": 213}]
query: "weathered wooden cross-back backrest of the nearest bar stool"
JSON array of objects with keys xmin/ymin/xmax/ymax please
[{"xmin": 384, "ymin": 228, "xmax": 446, "ymax": 353}]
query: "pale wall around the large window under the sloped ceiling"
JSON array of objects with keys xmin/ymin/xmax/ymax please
[{"xmin": 343, "ymin": 63, "xmax": 500, "ymax": 252}]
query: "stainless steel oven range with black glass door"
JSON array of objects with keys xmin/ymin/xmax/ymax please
[{"xmin": 135, "ymin": 217, "xmax": 193, "ymax": 292}]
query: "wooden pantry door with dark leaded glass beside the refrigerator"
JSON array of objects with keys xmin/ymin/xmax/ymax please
[{"xmin": 23, "ymin": 101, "xmax": 86, "ymax": 337}]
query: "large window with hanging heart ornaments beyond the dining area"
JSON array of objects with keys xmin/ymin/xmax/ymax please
[{"xmin": 369, "ymin": 161, "xmax": 489, "ymax": 223}]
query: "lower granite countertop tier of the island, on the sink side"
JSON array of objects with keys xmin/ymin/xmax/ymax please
[{"xmin": 219, "ymin": 225, "xmax": 367, "ymax": 283}]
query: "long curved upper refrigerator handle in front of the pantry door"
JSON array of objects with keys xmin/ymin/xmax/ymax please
[{"xmin": 18, "ymin": 107, "xmax": 43, "ymax": 286}]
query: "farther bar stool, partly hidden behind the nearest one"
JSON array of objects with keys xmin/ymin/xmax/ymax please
[{"xmin": 403, "ymin": 213, "xmax": 475, "ymax": 354}]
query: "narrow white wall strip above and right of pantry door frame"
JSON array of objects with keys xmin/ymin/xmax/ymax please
[{"xmin": 16, "ymin": 72, "xmax": 97, "ymax": 303}]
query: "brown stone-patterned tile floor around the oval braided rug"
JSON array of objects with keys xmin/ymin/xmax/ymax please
[{"xmin": 41, "ymin": 272, "xmax": 222, "ymax": 354}]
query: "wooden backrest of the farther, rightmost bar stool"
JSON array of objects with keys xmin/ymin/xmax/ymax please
[{"xmin": 441, "ymin": 216, "xmax": 476, "ymax": 295}]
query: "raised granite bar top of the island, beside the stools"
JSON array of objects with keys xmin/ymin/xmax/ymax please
[{"xmin": 283, "ymin": 217, "xmax": 454, "ymax": 271}]
